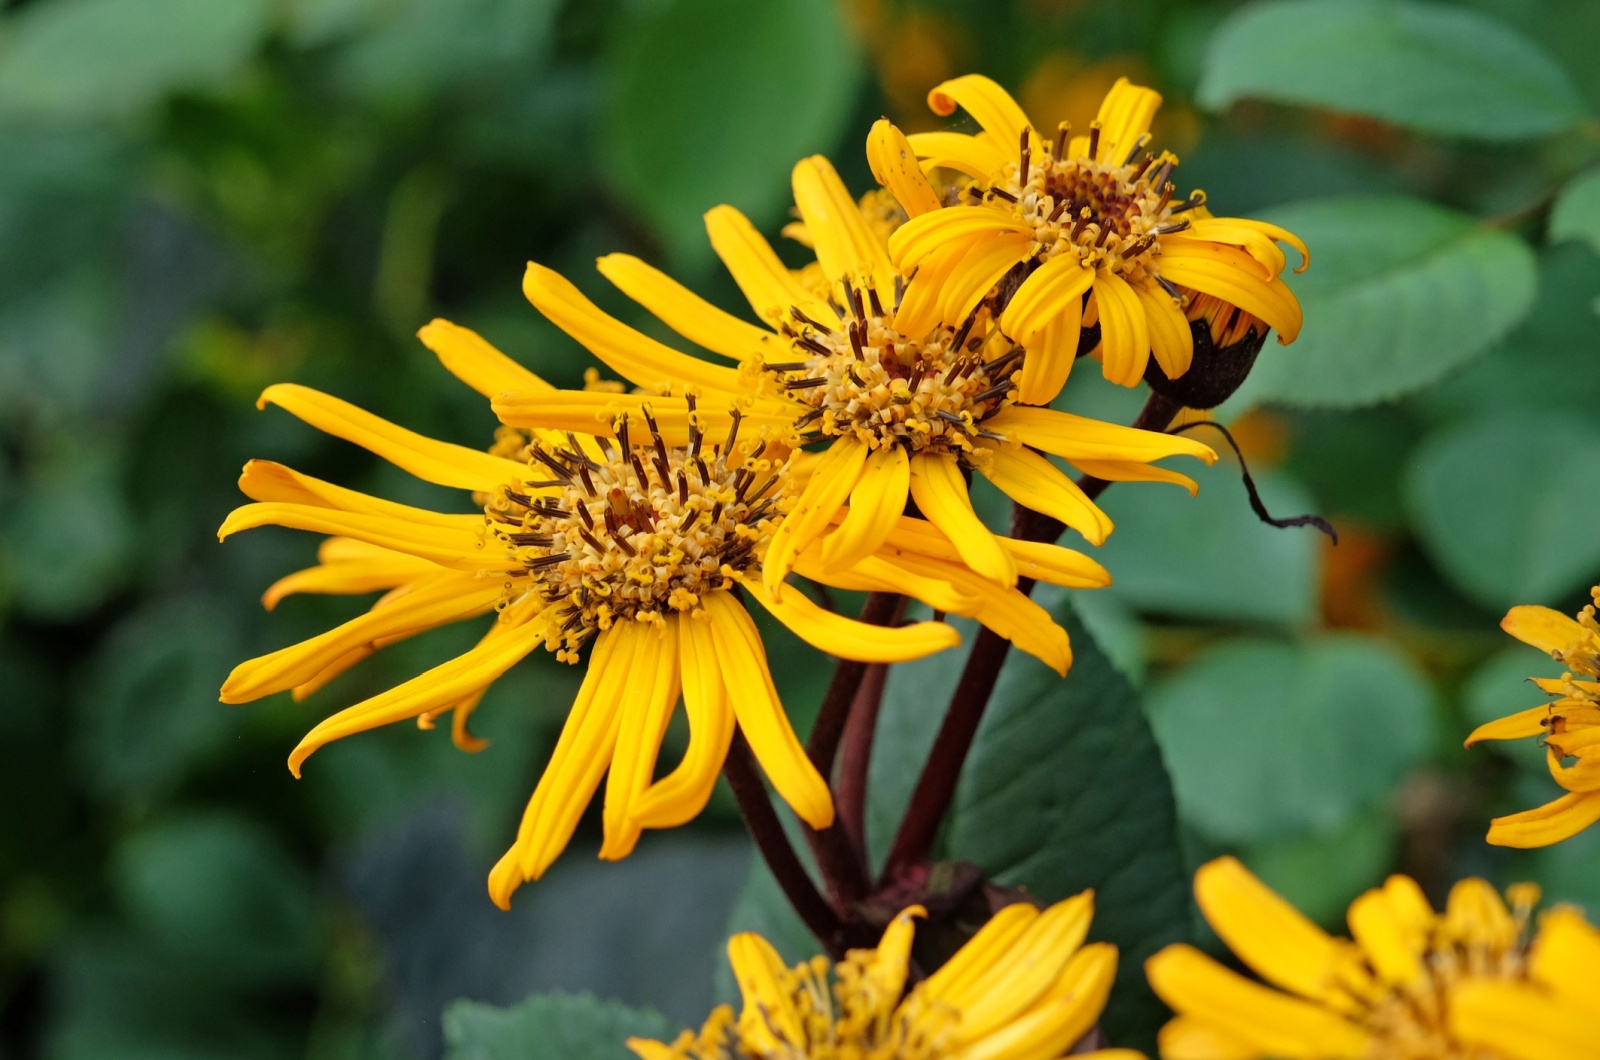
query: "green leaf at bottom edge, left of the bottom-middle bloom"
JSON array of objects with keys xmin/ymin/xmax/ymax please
[{"xmin": 445, "ymin": 993, "xmax": 678, "ymax": 1060}]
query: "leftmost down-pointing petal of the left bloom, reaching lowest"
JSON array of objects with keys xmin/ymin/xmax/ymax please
[{"xmin": 490, "ymin": 623, "xmax": 633, "ymax": 909}]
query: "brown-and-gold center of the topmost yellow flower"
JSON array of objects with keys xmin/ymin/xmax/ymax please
[{"xmin": 966, "ymin": 125, "xmax": 1205, "ymax": 280}]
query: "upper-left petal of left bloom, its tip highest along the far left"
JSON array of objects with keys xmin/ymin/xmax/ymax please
[{"xmin": 256, "ymin": 383, "xmax": 522, "ymax": 490}]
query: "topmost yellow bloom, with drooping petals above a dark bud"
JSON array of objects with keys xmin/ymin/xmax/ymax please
[{"xmin": 869, "ymin": 74, "xmax": 1309, "ymax": 393}]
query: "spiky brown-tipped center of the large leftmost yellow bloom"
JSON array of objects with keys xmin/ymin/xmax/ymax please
[{"xmin": 483, "ymin": 407, "xmax": 784, "ymax": 661}]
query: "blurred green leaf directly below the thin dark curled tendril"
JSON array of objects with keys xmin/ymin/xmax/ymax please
[{"xmin": 1094, "ymin": 461, "xmax": 1322, "ymax": 626}]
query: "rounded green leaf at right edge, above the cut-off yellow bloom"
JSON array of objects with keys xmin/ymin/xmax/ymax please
[{"xmin": 1405, "ymin": 413, "xmax": 1600, "ymax": 608}]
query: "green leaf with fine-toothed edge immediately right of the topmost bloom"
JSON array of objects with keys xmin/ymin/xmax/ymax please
[{"xmin": 1235, "ymin": 197, "xmax": 1536, "ymax": 408}]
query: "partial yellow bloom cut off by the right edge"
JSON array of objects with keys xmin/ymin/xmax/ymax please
[{"xmin": 1467, "ymin": 586, "xmax": 1600, "ymax": 847}]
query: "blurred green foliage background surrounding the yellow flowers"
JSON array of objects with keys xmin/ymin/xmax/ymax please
[{"xmin": 0, "ymin": 0, "xmax": 1600, "ymax": 1060}]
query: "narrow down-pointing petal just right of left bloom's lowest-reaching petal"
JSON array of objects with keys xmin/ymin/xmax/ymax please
[{"xmin": 600, "ymin": 620, "xmax": 682, "ymax": 861}]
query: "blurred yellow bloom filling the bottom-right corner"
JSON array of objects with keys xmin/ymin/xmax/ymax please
[{"xmin": 1146, "ymin": 858, "xmax": 1600, "ymax": 1060}]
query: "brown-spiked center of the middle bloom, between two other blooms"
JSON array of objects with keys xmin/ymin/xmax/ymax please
[{"xmin": 766, "ymin": 290, "xmax": 1022, "ymax": 455}]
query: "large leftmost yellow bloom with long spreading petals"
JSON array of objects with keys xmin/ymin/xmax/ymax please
[{"xmin": 218, "ymin": 320, "xmax": 960, "ymax": 906}]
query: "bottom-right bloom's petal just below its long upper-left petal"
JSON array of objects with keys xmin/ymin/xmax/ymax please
[{"xmin": 1144, "ymin": 945, "xmax": 1371, "ymax": 1060}]
